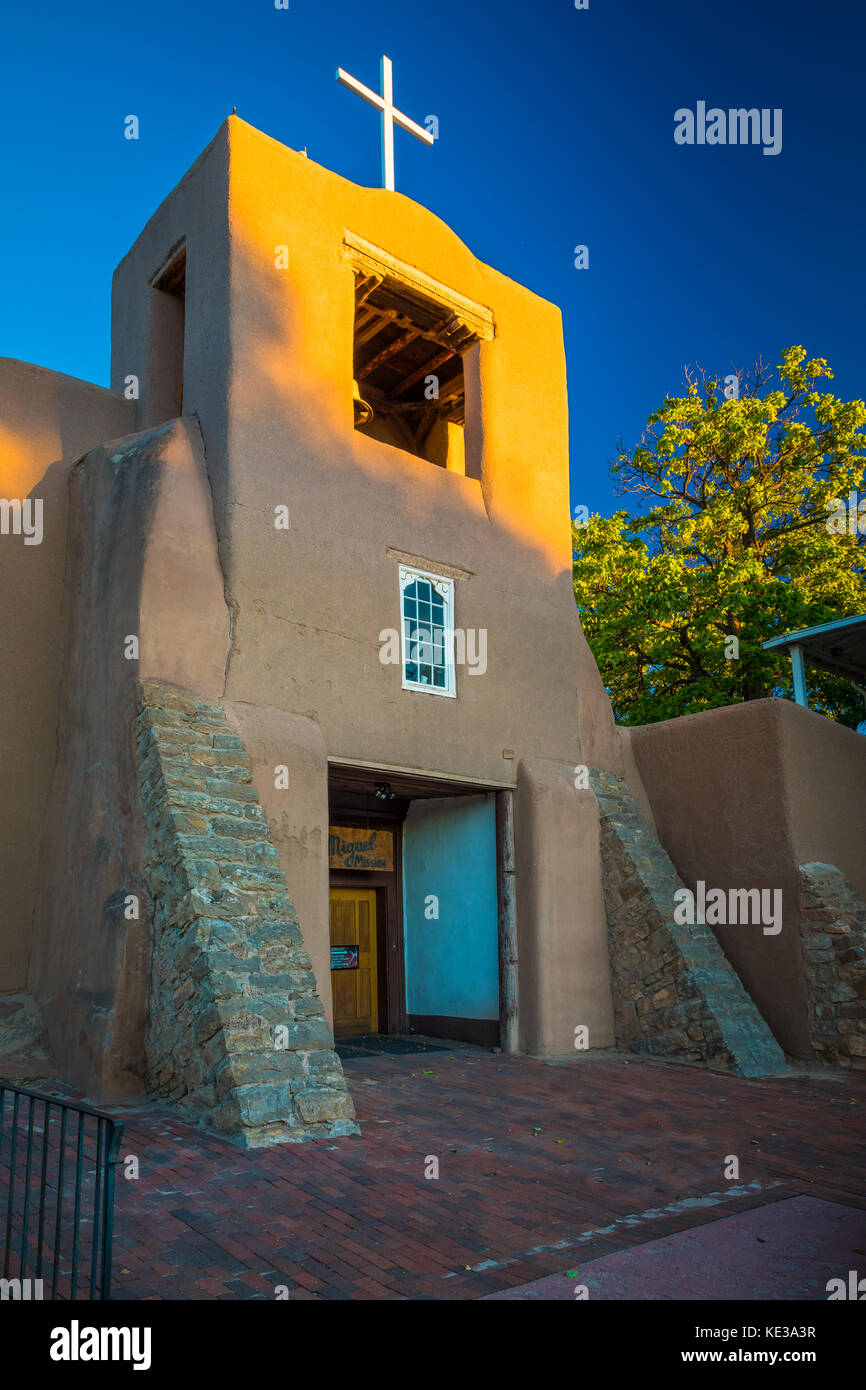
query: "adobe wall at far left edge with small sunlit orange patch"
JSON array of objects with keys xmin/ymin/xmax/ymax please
[{"xmin": 0, "ymin": 357, "xmax": 135, "ymax": 992}]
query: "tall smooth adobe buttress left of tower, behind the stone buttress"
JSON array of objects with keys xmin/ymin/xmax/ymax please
[{"xmin": 28, "ymin": 421, "xmax": 228, "ymax": 1101}]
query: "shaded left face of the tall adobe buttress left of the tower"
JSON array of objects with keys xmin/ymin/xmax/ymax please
[{"xmin": 31, "ymin": 417, "xmax": 191, "ymax": 1101}]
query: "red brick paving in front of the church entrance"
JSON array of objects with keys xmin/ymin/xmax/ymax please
[{"xmin": 103, "ymin": 1048, "xmax": 866, "ymax": 1300}]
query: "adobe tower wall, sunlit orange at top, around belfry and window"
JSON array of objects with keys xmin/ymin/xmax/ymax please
[{"xmin": 104, "ymin": 117, "xmax": 639, "ymax": 1052}]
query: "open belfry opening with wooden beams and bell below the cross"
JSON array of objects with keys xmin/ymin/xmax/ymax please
[{"xmin": 353, "ymin": 271, "xmax": 477, "ymax": 473}]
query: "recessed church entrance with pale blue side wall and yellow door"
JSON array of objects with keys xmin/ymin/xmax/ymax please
[{"xmin": 328, "ymin": 763, "xmax": 512, "ymax": 1047}]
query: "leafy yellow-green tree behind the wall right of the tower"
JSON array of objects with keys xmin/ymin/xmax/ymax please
[{"xmin": 574, "ymin": 348, "xmax": 866, "ymax": 726}]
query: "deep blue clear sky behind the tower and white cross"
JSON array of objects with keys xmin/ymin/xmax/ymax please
[{"xmin": 0, "ymin": 0, "xmax": 866, "ymax": 512}]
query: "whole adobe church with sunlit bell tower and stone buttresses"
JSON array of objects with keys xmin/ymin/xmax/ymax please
[{"xmin": 0, "ymin": 117, "xmax": 866, "ymax": 1145}]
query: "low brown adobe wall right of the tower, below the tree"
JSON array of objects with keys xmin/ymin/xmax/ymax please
[{"xmin": 630, "ymin": 699, "xmax": 866, "ymax": 1056}]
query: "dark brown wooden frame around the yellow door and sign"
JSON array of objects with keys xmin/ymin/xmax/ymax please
[{"xmin": 328, "ymin": 812, "xmax": 409, "ymax": 1033}]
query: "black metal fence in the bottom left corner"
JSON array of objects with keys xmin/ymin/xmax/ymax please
[{"xmin": 0, "ymin": 1080, "xmax": 124, "ymax": 1300}]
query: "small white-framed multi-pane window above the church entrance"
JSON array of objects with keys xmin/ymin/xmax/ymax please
[{"xmin": 400, "ymin": 564, "xmax": 457, "ymax": 699}]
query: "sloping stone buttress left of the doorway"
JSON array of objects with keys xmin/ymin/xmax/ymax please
[{"xmin": 138, "ymin": 681, "xmax": 359, "ymax": 1147}]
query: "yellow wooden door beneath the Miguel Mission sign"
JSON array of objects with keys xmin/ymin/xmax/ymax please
[{"xmin": 331, "ymin": 888, "xmax": 379, "ymax": 1038}]
